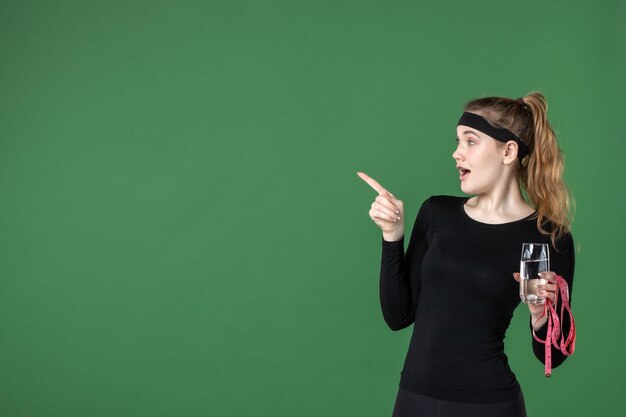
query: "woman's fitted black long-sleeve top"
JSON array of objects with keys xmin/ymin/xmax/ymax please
[{"xmin": 380, "ymin": 196, "xmax": 574, "ymax": 403}]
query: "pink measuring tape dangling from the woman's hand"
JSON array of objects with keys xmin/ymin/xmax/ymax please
[{"xmin": 533, "ymin": 275, "xmax": 576, "ymax": 378}]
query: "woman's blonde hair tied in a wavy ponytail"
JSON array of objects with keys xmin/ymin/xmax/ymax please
[{"xmin": 464, "ymin": 92, "xmax": 572, "ymax": 246}]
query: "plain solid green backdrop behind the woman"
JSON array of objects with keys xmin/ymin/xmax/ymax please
[{"xmin": 0, "ymin": 1, "xmax": 626, "ymax": 417}]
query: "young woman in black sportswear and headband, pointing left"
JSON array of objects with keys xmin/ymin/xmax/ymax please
[{"xmin": 358, "ymin": 92, "xmax": 574, "ymax": 417}]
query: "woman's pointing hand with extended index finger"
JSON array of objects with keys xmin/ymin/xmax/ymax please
[{"xmin": 357, "ymin": 172, "xmax": 404, "ymax": 242}]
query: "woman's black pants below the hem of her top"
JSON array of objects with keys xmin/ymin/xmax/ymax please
[{"xmin": 392, "ymin": 388, "xmax": 526, "ymax": 417}]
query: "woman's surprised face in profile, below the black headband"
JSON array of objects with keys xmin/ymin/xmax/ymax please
[{"xmin": 452, "ymin": 125, "xmax": 505, "ymax": 194}]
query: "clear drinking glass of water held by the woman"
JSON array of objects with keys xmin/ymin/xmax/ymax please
[{"xmin": 519, "ymin": 243, "xmax": 550, "ymax": 304}]
